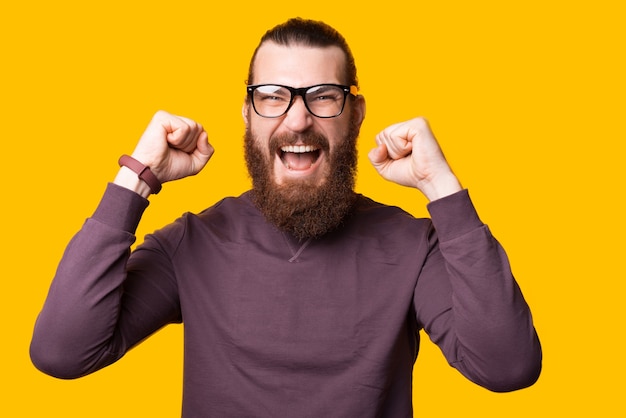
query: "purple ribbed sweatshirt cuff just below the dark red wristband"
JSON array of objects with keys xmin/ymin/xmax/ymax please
[{"xmin": 92, "ymin": 183, "xmax": 150, "ymax": 234}]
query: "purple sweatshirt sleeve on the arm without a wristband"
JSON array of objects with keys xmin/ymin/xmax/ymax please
[{"xmin": 414, "ymin": 190, "xmax": 542, "ymax": 392}]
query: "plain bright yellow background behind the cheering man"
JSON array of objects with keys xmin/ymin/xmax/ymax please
[{"xmin": 0, "ymin": 0, "xmax": 626, "ymax": 418}]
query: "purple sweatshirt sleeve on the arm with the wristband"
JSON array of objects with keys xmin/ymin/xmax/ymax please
[{"xmin": 31, "ymin": 184, "xmax": 180, "ymax": 378}]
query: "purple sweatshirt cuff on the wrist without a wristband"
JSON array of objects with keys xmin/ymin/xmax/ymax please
[{"xmin": 427, "ymin": 189, "xmax": 484, "ymax": 242}]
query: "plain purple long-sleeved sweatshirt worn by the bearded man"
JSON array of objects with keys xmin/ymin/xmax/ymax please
[{"xmin": 31, "ymin": 185, "xmax": 541, "ymax": 418}]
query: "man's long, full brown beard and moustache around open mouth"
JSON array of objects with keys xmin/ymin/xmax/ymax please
[{"xmin": 244, "ymin": 117, "xmax": 359, "ymax": 241}]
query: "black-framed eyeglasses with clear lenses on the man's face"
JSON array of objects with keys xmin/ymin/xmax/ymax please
[{"xmin": 247, "ymin": 84, "xmax": 357, "ymax": 118}]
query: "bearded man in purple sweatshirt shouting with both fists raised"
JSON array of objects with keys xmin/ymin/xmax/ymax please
[{"xmin": 31, "ymin": 19, "xmax": 541, "ymax": 417}]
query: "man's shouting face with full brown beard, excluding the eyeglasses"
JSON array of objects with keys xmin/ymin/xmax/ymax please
[{"xmin": 243, "ymin": 43, "xmax": 365, "ymax": 239}]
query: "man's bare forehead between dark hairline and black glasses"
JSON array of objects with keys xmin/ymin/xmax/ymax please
[{"xmin": 251, "ymin": 42, "xmax": 346, "ymax": 87}]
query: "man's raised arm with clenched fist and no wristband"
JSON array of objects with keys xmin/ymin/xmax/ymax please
[{"xmin": 369, "ymin": 118, "xmax": 542, "ymax": 391}]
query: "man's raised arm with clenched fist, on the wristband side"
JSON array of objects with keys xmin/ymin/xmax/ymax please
[{"xmin": 31, "ymin": 112, "xmax": 213, "ymax": 378}]
